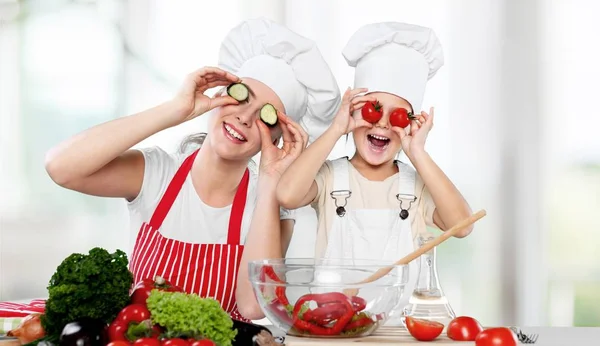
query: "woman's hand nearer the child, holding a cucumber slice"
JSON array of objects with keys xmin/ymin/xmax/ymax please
[{"xmin": 256, "ymin": 111, "xmax": 308, "ymax": 180}]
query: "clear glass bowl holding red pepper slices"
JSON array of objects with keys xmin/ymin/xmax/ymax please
[{"xmin": 249, "ymin": 258, "xmax": 408, "ymax": 338}]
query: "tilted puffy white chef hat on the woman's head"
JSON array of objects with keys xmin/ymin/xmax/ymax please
[{"xmin": 219, "ymin": 18, "xmax": 340, "ymax": 142}]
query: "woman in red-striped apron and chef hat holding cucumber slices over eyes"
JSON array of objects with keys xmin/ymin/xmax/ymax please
[{"xmin": 46, "ymin": 19, "xmax": 339, "ymax": 320}]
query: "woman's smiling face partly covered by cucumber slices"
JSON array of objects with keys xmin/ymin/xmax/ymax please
[{"xmin": 207, "ymin": 78, "xmax": 284, "ymax": 160}]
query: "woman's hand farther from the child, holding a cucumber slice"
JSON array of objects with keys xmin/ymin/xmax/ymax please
[{"xmin": 172, "ymin": 67, "xmax": 240, "ymax": 124}]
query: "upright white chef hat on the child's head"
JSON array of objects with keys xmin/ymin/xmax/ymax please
[{"xmin": 342, "ymin": 22, "xmax": 444, "ymax": 113}]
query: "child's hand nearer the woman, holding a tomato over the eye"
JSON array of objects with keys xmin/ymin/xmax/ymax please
[{"xmin": 330, "ymin": 88, "xmax": 376, "ymax": 136}]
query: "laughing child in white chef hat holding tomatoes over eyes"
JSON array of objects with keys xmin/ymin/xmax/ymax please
[{"xmin": 277, "ymin": 23, "xmax": 471, "ymax": 318}]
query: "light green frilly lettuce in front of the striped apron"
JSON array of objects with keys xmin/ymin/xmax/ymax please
[{"xmin": 146, "ymin": 290, "xmax": 237, "ymax": 346}]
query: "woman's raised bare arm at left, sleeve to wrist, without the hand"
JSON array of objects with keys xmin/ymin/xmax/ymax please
[{"xmin": 46, "ymin": 103, "xmax": 178, "ymax": 200}]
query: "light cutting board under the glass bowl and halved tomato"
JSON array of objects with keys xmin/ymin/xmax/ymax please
[{"xmin": 285, "ymin": 327, "xmax": 475, "ymax": 346}]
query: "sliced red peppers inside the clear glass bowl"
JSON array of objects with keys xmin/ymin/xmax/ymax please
[{"xmin": 263, "ymin": 266, "xmax": 375, "ymax": 337}]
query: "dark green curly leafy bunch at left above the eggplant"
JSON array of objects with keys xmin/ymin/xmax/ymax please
[{"xmin": 42, "ymin": 248, "xmax": 133, "ymax": 340}]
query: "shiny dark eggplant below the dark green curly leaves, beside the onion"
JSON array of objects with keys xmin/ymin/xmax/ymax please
[{"xmin": 59, "ymin": 319, "xmax": 109, "ymax": 346}]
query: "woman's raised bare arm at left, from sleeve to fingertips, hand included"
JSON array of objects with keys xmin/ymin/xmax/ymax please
[{"xmin": 46, "ymin": 67, "xmax": 238, "ymax": 200}]
